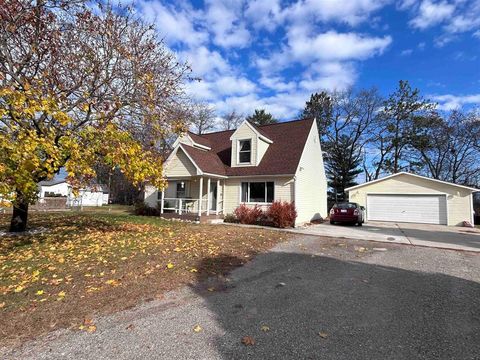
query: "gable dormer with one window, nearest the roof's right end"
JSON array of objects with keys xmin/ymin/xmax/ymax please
[{"xmin": 230, "ymin": 120, "xmax": 272, "ymax": 167}]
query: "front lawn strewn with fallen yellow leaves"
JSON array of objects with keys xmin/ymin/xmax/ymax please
[{"xmin": 0, "ymin": 211, "xmax": 287, "ymax": 345}]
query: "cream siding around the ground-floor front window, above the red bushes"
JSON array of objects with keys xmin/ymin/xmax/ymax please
[{"xmin": 225, "ymin": 177, "xmax": 294, "ymax": 214}]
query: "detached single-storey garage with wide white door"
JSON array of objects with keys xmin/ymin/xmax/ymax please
[{"xmin": 346, "ymin": 172, "xmax": 478, "ymax": 226}]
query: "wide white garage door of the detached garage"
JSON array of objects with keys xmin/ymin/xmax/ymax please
[{"xmin": 367, "ymin": 195, "xmax": 447, "ymax": 225}]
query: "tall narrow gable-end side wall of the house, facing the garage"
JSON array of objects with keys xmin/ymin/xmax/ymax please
[{"xmin": 295, "ymin": 121, "xmax": 327, "ymax": 225}]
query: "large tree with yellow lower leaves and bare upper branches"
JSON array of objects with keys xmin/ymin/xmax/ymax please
[{"xmin": 0, "ymin": 0, "xmax": 188, "ymax": 231}]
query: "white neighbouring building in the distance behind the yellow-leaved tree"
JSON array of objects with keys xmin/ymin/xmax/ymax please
[{"xmin": 38, "ymin": 179, "xmax": 108, "ymax": 206}]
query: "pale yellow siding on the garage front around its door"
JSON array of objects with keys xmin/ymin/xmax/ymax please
[{"xmin": 349, "ymin": 174, "xmax": 472, "ymax": 226}]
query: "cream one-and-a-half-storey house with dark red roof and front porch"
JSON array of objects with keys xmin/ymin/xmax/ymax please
[{"xmin": 145, "ymin": 119, "xmax": 327, "ymax": 225}]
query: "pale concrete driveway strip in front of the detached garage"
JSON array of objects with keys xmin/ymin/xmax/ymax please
[{"xmin": 296, "ymin": 221, "xmax": 480, "ymax": 252}]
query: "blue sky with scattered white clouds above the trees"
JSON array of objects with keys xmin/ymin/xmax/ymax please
[{"xmin": 122, "ymin": 0, "xmax": 480, "ymax": 120}]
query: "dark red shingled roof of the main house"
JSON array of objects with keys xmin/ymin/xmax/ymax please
[{"xmin": 177, "ymin": 119, "xmax": 314, "ymax": 176}]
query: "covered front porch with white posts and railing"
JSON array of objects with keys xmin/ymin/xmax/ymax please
[{"xmin": 158, "ymin": 176, "xmax": 225, "ymax": 215}]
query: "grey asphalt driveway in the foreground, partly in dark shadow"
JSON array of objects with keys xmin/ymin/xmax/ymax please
[{"xmin": 0, "ymin": 235, "xmax": 480, "ymax": 360}]
